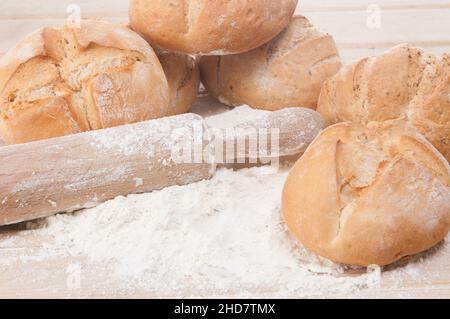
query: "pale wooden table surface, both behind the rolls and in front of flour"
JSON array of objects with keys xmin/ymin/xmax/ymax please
[{"xmin": 0, "ymin": 0, "xmax": 450, "ymax": 298}]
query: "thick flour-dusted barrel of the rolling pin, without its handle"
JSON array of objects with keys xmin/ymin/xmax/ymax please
[{"xmin": 0, "ymin": 114, "xmax": 211, "ymax": 224}]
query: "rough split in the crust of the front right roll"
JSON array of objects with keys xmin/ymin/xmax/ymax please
[{"xmin": 335, "ymin": 123, "xmax": 450, "ymax": 240}]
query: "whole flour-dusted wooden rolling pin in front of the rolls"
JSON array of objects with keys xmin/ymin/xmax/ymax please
[{"xmin": 0, "ymin": 108, "xmax": 323, "ymax": 225}]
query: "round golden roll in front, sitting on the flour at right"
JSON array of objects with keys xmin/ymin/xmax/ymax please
[{"xmin": 282, "ymin": 123, "xmax": 450, "ymax": 266}]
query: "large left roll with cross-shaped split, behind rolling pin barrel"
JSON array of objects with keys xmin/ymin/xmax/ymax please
[{"xmin": 0, "ymin": 21, "xmax": 169, "ymax": 144}]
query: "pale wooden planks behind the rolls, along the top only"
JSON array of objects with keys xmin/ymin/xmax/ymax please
[{"xmin": 0, "ymin": 0, "xmax": 450, "ymax": 61}]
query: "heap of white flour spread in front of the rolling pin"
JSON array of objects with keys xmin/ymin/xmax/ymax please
[{"xmin": 4, "ymin": 108, "xmax": 446, "ymax": 297}]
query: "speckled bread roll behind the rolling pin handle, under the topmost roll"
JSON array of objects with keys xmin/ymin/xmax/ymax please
[{"xmin": 200, "ymin": 16, "xmax": 341, "ymax": 111}]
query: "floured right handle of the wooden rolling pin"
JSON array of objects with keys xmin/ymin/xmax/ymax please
[{"xmin": 205, "ymin": 105, "xmax": 324, "ymax": 164}]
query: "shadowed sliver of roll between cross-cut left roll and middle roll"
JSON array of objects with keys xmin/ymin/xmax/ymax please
[{"xmin": 156, "ymin": 49, "xmax": 200, "ymax": 116}]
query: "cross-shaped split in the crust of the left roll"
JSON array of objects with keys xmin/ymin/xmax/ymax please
[{"xmin": 1, "ymin": 27, "xmax": 146, "ymax": 136}]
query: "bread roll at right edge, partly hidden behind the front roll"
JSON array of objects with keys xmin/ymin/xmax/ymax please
[{"xmin": 318, "ymin": 44, "xmax": 450, "ymax": 160}]
